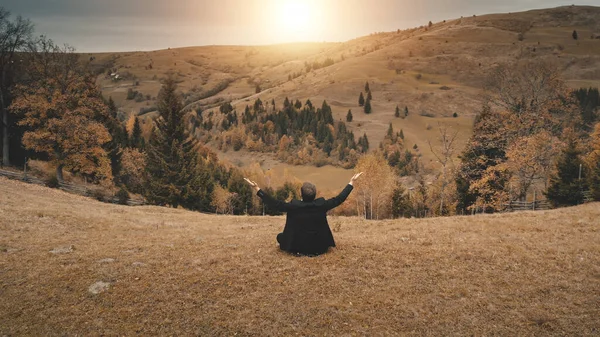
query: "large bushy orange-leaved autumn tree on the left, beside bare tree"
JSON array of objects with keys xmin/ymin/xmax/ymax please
[{"xmin": 10, "ymin": 43, "xmax": 112, "ymax": 181}]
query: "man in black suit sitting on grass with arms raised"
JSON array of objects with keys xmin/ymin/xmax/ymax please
[{"xmin": 244, "ymin": 172, "xmax": 362, "ymax": 255}]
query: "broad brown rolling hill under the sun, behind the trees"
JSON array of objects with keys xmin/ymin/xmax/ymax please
[{"xmin": 89, "ymin": 6, "xmax": 600, "ymax": 188}]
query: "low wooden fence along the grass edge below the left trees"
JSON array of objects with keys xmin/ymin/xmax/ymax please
[{"xmin": 0, "ymin": 169, "xmax": 146, "ymax": 206}]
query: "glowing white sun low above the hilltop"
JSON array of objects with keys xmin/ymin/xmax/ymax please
[{"xmin": 272, "ymin": 0, "xmax": 321, "ymax": 42}]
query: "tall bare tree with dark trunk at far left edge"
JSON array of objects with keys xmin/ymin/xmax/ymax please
[{"xmin": 0, "ymin": 7, "xmax": 33, "ymax": 165}]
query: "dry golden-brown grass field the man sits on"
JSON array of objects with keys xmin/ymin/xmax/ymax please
[{"xmin": 0, "ymin": 178, "xmax": 600, "ymax": 336}]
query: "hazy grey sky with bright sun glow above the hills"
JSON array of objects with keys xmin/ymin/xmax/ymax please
[{"xmin": 0, "ymin": 0, "xmax": 600, "ymax": 52}]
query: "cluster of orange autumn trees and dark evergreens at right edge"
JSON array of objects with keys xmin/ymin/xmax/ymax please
[{"xmin": 455, "ymin": 62, "xmax": 599, "ymax": 212}]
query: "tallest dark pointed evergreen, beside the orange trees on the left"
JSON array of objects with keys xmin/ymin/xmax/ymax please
[{"xmin": 145, "ymin": 77, "xmax": 212, "ymax": 209}]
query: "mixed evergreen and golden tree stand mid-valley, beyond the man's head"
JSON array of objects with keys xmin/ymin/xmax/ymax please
[{"xmin": 191, "ymin": 98, "xmax": 369, "ymax": 168}]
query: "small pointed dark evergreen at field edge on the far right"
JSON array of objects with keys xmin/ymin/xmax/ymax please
[{"xmin": 546, "ymin": 137, "xmax": 586, "ymax": 207}]
